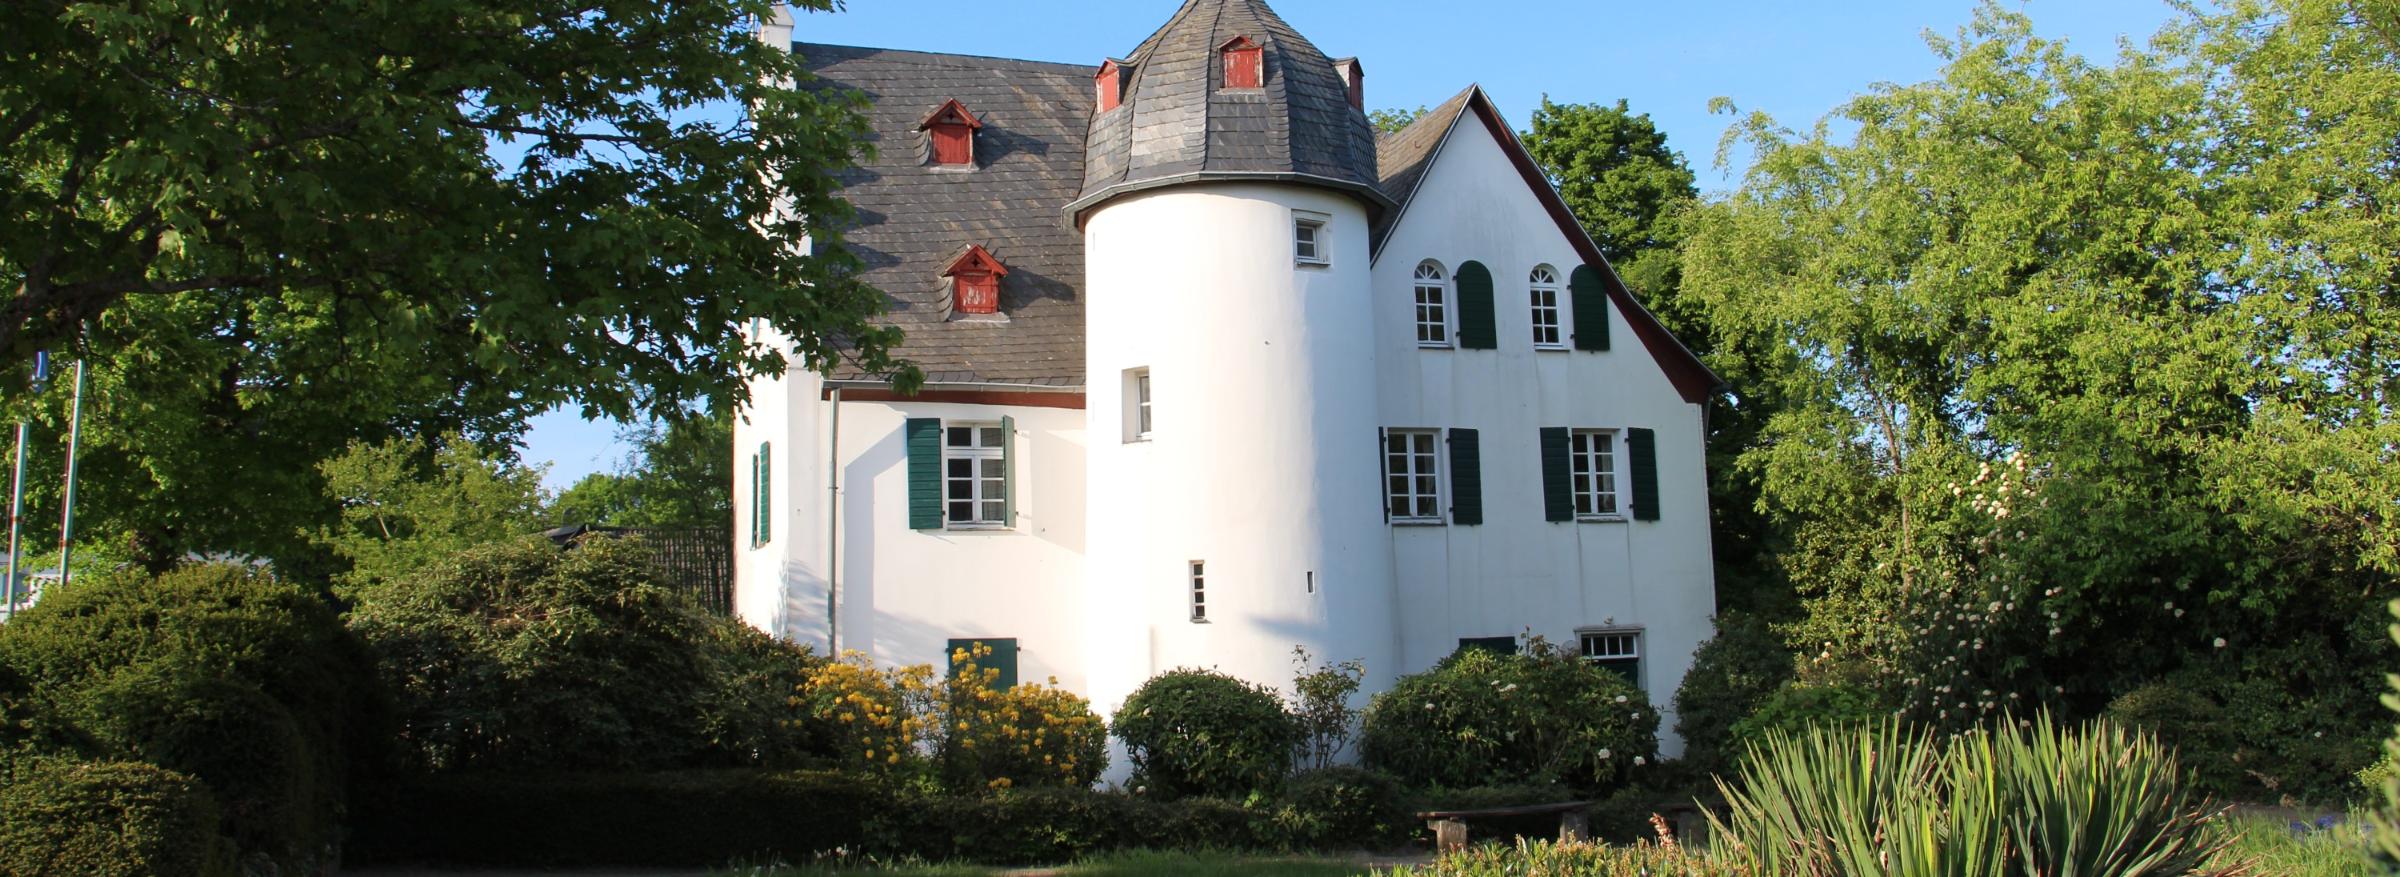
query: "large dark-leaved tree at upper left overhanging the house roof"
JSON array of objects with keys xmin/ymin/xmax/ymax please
[{"xmin": 0, "ymin": 0, "xmax": 914, "ymax": 565}]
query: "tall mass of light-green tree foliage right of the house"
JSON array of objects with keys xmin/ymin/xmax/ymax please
[{"xmin": 1682, "ymin": 0, "xmax": 2400, "ymax": 793}]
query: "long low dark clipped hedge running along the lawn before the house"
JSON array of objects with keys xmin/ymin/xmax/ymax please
[{"xmin": 348, "ymin": 771, "xmax": 1406, "ymax": 867}]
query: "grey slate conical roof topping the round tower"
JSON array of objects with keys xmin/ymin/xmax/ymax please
[{"xmin": 1068, "ymin": 0, "xmax": 1390, "ymax": 221}]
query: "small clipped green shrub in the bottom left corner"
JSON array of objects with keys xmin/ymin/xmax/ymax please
[{"xmin": 0, "ymin": 759, "xmax": 233, "ymax": 877}]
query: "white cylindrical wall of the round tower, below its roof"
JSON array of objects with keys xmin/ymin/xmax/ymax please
[{"xmin": 1085, "ymin": 183, "xmax": 1397, "ymax": 711}]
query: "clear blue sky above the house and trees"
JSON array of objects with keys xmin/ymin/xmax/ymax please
[{"xmin": 526, "ymin": 0, "xmax": 2177, "ymax": 488}]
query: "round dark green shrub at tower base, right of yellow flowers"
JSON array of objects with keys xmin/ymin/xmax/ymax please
[{"xmin": 1111, "ymin": 668, "xmax": 1301, "ymax": 798}]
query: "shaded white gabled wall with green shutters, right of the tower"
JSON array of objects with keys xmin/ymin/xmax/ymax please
[{"xmin": 1375, "ymin": 113, "xmax": 1716, "ymax": 754}]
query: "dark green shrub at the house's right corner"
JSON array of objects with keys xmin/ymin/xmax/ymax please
[{"xmin": 1675, "ymin": 613, "xmax": 1793, "ymax": 771}]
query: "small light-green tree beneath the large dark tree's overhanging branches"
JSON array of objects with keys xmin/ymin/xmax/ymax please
[{"xmin": 314, "ymin": 435, "xmax": 550, "ymax": 584}]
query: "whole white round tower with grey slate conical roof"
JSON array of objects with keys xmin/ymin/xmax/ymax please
[{"xmin": 1068, "ymin": 0, "xmax": 1397, "ymax": 725}]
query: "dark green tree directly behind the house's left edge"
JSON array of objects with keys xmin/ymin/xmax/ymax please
[{"xmin": 550, "ymin": 408, "xmax": 734, "ymax": 531}]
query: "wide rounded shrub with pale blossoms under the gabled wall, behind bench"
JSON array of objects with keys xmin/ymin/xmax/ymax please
[{"xmin": 1363, "ymin": 639, "xmax": 1658, "ymax": 791}]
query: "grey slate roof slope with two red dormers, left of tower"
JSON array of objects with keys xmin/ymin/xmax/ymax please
[{"xmin": 792, "ymin": 43, "xmax": 1094, "ymax": 389}]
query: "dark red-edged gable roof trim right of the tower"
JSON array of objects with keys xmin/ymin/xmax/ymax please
[{"xmin": 1370, "ymin": 86, "xmax": 1726, "ymax": 404}]
